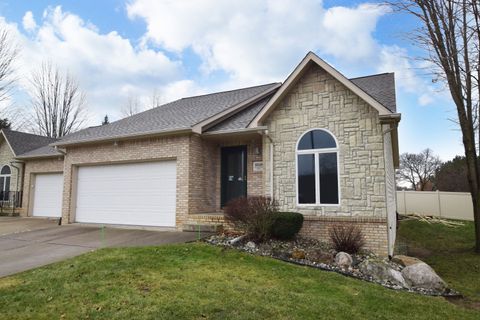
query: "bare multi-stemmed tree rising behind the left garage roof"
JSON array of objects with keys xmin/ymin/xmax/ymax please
[{"xmin": 30, "ymin": 62, "xmax": 87, "ymax": 138}]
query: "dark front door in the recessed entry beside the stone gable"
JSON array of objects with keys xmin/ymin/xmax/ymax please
[{"xmin": 221, "ymin": 146, "xmax": 247, "ymax": 207}]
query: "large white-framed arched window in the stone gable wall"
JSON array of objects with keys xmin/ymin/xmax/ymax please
[{"xmin": 297, "ymin": 129, "xmax": 340, "ymax": 205}]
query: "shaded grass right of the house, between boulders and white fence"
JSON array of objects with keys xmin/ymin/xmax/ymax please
[{"xmin": 397, "ymin": 220, "xmax": 480, "ymax": 309}]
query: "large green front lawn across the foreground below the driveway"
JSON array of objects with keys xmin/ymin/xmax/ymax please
[{"xmin": 0, "ymin": 244, "xmax": 480, "ymax": 320}]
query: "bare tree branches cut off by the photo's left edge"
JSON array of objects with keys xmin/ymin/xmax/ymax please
[{"xmin": 0, "ymin": 30, "xmax": 19, "ymax": 101}]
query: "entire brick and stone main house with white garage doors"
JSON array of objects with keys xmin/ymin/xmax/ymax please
[{"xmin": 17, "ymin": 53, "xmax": 400, "ymax": 255}]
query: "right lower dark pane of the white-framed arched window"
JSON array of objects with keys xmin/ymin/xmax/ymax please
[{"xmin": 318, "ymin": 152, "xmax": 338, "ymax": 204}]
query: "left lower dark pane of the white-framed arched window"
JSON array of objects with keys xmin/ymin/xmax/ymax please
[{"xmin": 298, "ymin": 154, "xmax": 315, "ymax": 203}]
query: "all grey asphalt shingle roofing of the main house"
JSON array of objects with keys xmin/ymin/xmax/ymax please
[{"xmin": 46, "ymin": 73, "xmax": 396, "ymax": 148}]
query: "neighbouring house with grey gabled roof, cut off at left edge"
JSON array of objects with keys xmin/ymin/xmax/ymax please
[{"xmin": 0, "ymin": 129, "xmax": 56, "ymax": 207}]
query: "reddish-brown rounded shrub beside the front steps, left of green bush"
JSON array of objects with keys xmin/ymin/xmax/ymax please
[{"xmin": 225, "ymin": 197, "xmax": 278, "ymax": 241}]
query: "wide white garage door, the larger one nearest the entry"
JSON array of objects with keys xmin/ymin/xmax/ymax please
[{"xmin": 75, "ymin": 161, "xmax": 177, "ymax": 227}]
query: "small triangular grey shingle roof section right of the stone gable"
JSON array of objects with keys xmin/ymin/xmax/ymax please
[{"xmin": 350, "ymin": 73, "xmax": 397, "ymax": 113}]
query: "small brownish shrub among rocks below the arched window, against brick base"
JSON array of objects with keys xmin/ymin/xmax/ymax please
[{"xmin": 330, "ymin": 225, "xmax": 365, "ymax": 253}]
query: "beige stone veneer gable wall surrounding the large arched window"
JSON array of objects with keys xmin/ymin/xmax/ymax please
[{"xmin": 263, "ymin": 65, "xmax": 387, "ymax": 252}]
